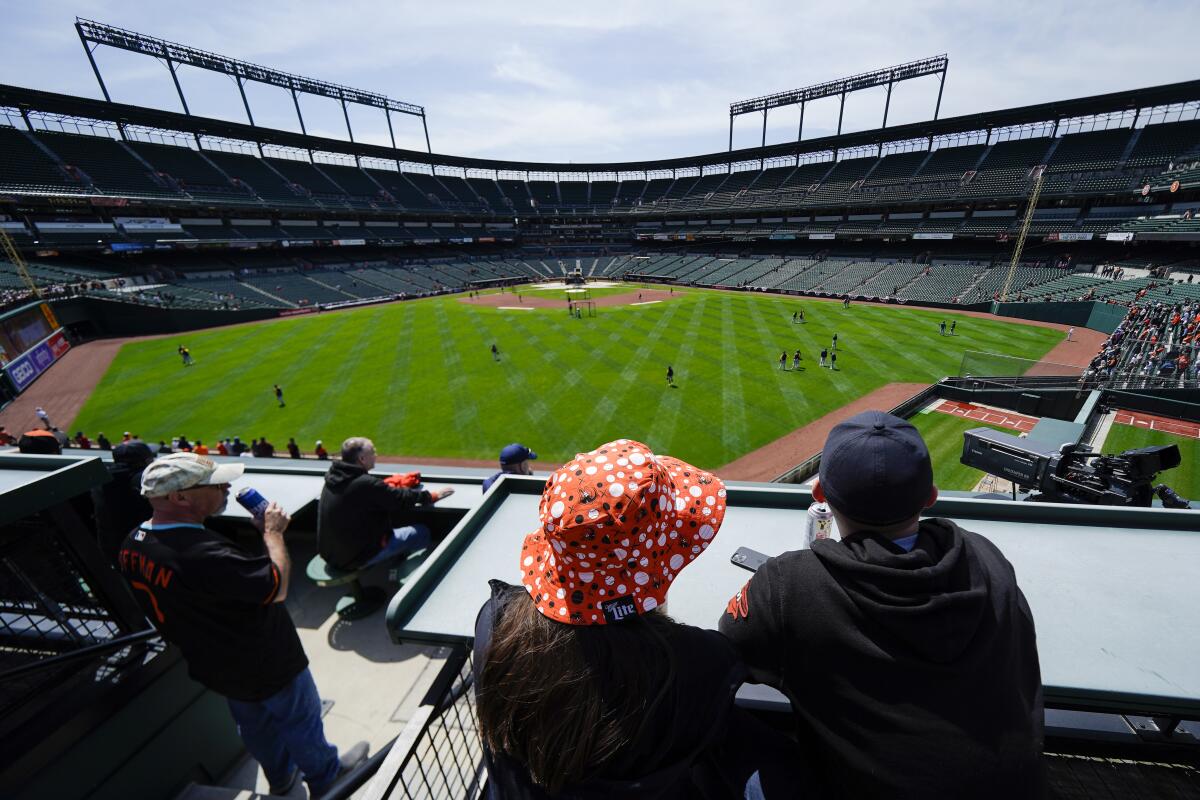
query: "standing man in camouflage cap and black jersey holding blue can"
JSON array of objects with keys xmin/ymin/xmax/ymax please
[{"xmin": 118, "ymin": 453, "xmax": 367, "ymax": 796}]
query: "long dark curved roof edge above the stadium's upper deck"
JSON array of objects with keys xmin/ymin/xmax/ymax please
[{"xmin": 0, "ymin": 80, "xmax": 1200, "ymax": 173}]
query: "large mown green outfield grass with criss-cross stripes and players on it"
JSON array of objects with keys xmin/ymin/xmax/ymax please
[{"xmin": 71, "ymin": 290, "xmax": 1062, "ymax": 468}]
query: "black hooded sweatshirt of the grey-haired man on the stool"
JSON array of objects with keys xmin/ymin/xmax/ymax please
[{"xmin": 317, "ymin": 461, "xmax": 432, "ymax": 570}]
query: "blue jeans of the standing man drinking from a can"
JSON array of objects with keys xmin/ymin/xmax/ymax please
[{"xmin": 226, "ymin": 667, "xmax": 338, "ymax": 794}]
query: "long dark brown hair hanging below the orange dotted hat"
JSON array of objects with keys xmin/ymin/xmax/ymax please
[{"xmin": 476, "ymin": 591, "xmax": 676, "ymax": 793}]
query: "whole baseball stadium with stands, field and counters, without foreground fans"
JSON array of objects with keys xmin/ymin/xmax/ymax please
[{"xmin": 0, "ymin": 10, "xmax": 1200, "ymax": 800}]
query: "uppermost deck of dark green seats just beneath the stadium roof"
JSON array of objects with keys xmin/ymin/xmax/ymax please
[{"xmin": 9, "ymin": 113, "xmax": 1200, "ymax": 219}]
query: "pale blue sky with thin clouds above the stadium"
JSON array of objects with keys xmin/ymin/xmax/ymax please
[{"xmin": 0, "ymin": 0, "xmax": 1200, "ymax": 161}]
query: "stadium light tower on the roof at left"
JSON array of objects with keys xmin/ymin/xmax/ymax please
[{"xmin": 76, "ymin": 17, "xmax": 433, "ymax": 154}]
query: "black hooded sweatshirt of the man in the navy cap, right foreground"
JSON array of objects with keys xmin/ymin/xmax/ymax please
[{"xmin": 720, "ymin": 519, "xmax": 1043, "ymax": 800}]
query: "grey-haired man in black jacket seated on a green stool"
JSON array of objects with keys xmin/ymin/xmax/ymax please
[{"xmin": 317, "ymin": 437, "xmax": 454, "ymax": 570}]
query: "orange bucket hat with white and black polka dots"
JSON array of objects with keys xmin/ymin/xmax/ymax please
[{"xmin": 521, "ymin": 439, "xmax": 725, "ymax": 625}]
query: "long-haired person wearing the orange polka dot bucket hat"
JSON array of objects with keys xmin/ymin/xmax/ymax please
[{"xmin": 473, "ymin": 439, "xmax": 810, "ymax": 798}]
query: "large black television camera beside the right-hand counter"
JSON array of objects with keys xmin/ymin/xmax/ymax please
[{"xmin": 961, "ymin": 428, "xmax": 1190, "ymax": 509}]
